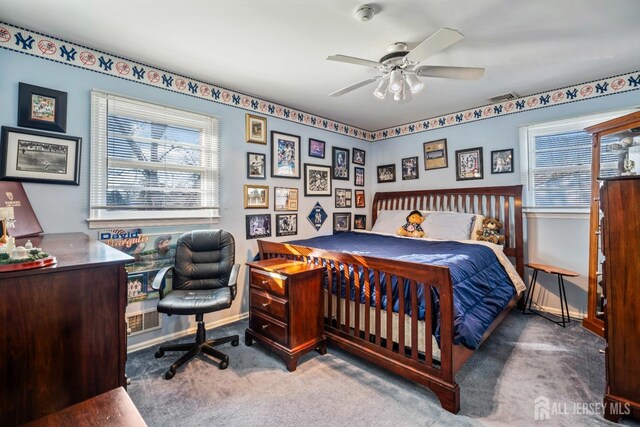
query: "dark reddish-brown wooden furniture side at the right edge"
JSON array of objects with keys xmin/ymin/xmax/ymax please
[{"xmin": 600, "ymin": 176, "xmax": 640, "ymax": 421}]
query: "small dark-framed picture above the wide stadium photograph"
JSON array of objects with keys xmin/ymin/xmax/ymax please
[{"xmin": 18, "ymin": 83, "xmax": 67, "ymax": 133}]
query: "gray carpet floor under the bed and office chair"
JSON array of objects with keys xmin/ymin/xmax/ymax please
[{"xmin": 127, "ymin": 311, "xmax": 640, "ymax": 427}]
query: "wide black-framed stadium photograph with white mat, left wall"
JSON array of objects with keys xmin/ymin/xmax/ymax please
[{"xmin": 0, "ymin": 126, "xmax": 82, "ymax": 185}]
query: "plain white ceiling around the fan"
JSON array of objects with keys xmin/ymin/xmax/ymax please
[{"xmin": 0, "ymin": 0, "xmax": 640, "ymax": 131}]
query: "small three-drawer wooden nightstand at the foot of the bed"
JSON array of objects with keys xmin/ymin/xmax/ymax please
[{"xmin": 245, "ymin": 258, "xmax": 327, "ymax": 371}]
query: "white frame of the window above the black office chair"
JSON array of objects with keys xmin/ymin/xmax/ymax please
[{"xmin": 87, "ymin": 90, "xmax": 222, "ymax": 229}]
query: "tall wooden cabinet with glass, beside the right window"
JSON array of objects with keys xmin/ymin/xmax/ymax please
[{"xmin": 582, "ymin": 112, "xmax": 640, "ymax": 336}]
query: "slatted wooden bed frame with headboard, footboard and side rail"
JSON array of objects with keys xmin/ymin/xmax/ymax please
[{"xmin": 258, "ymin": 185, "xmax": 524, "ymax": 413}]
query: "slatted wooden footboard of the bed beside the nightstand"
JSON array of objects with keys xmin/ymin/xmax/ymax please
[{"xmin": 258, "ymin": 240, "xmax": 460, "ymax": 413}]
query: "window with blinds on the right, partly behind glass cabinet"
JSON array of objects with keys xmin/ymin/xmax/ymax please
[{"xmin": 520, "ymin": 111, "xmax": 630, "ymax": 212}]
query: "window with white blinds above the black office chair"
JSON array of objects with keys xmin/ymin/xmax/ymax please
[{"xmin": 89, "ymin": 92, "xmax": 220, "ymax": 227}]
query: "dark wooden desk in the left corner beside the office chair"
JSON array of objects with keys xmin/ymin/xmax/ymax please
[{"xmin": 0, "ymin": 233, "xmax": 132, "ymax": 426}]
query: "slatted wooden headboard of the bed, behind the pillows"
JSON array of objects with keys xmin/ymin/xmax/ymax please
[{"xmin": 371, "ymin": 185, "xmax": 524, "ymax": 277}]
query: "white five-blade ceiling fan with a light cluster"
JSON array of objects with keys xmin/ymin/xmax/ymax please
[{"xmin": 327, "ymin": 28, "xmax": 484, "ymax": 101}]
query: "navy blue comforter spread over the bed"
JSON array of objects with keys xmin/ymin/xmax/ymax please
[{"xmin": 287, "ymin": 232, "xmax": 516, "ymax": 350}]
